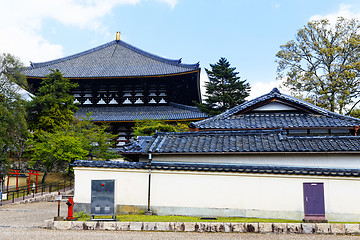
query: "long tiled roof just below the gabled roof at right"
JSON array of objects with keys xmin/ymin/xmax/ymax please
[{"xmin": 122, "ymin": 130, "xmax": 360, "ymax": 155}]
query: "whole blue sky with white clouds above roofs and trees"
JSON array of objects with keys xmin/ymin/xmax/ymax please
[{"xmin": 0, "ymin": 0, "xmax": 360, "ymax": 99}]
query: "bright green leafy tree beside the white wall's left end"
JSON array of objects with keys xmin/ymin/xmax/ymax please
[{"xmin": 29, "ymin": 115, "xmax": 119, "ymax": 183}]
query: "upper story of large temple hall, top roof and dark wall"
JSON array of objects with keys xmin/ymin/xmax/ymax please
[{"xmin": 25, "ymin": 37, "xmax": 201, "ymax": 106}]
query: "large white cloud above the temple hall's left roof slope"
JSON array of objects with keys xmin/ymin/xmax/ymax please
[{"xmin": 0, "ymin": 0, "xmax": 177, "ymax": 65}]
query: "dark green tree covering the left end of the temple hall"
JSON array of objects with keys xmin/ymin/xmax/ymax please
[{"xmin": 28, "ymin": 70, "xmax": 78, "ymax": 132}]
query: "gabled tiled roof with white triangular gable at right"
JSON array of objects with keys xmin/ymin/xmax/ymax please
[{"xmin": 192, "ymin": 88, "xmax": 360, "ymax": 129}]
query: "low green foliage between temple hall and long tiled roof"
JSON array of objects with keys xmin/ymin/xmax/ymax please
[{"xmin": 133, "ymin": 119, "xmax": 189, "ymax": 137}]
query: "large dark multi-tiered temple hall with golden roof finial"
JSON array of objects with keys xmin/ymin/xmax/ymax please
[{"xmin": 25, "ymin": 33, "xmax": 207, "ymax": 145}]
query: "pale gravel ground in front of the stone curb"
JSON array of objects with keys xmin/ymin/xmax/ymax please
[{"xmin": 0, "ymin": 202, "xmax": 360, "ymax": 240}]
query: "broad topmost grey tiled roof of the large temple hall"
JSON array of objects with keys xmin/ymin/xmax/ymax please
[{"xmin": 25, "ymin": 41, "xmax": 199, "ymax": 78}]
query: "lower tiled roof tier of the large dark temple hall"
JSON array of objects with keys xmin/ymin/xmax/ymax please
[{"xmin": 75, "ymin": 103, "xmax": 207, "ymax": 122}]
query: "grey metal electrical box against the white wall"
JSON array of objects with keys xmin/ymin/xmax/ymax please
[{"xmin": 91, "ymin": 180, "xmax": 116, "ymax": 219}]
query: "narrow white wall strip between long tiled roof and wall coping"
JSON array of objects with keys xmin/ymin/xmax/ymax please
[{"xmin": 152, "ymin": 153, "xmax": 360, "ymax": 169}]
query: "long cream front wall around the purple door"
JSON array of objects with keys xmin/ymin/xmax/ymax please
[{"xmin": 74, "ymin": 167, "xmax": 360, "ymax": 221}]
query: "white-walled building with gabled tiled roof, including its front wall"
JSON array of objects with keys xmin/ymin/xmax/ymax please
[{"xmin": 74, "ymin": 89, "xmax": 360, "ymax": 221}]
